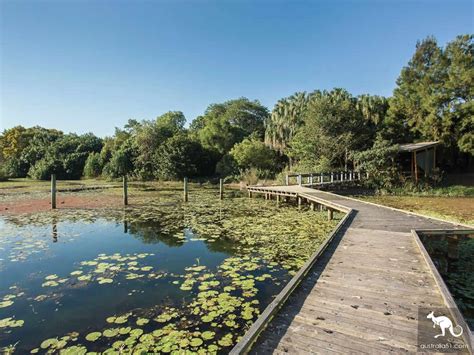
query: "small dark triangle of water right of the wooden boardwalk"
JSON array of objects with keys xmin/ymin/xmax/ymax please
[{"xmin": 419, "ymin": 233, "xmax": 474, "ymax": 330}]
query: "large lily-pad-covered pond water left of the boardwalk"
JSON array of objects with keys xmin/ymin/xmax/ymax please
[{"xmin": 0, "ymin": 188, "xmax": 342, "ymax": 354}]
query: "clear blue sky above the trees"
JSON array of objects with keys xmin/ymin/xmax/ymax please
[{"xmin": 0, "ymin": 0, "xmax": 474, "ymax": 136}]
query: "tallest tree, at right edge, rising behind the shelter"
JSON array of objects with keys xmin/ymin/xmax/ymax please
[{"xmin": 389, "ymin": 35, "xmax": 474, "ymax": 169}]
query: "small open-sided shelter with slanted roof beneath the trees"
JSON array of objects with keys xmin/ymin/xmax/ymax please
[{"xmin": 398, "ymin": 142, "xmax": 440, "ymax": 182}]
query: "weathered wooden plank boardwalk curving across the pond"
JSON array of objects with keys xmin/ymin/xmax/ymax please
[{"xmin": 232, "ymin": 186, "xmax": 470, "ymax": 354}]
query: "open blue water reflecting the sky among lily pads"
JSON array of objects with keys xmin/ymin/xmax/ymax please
[{"xmin": 0, "ymin": 219, "xmax": 287, "ymax": 350}]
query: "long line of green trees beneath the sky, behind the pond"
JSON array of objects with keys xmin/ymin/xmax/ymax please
[{"xmin": 0, "ymin": 35, "xmax": 474, "ymax": 184}]
